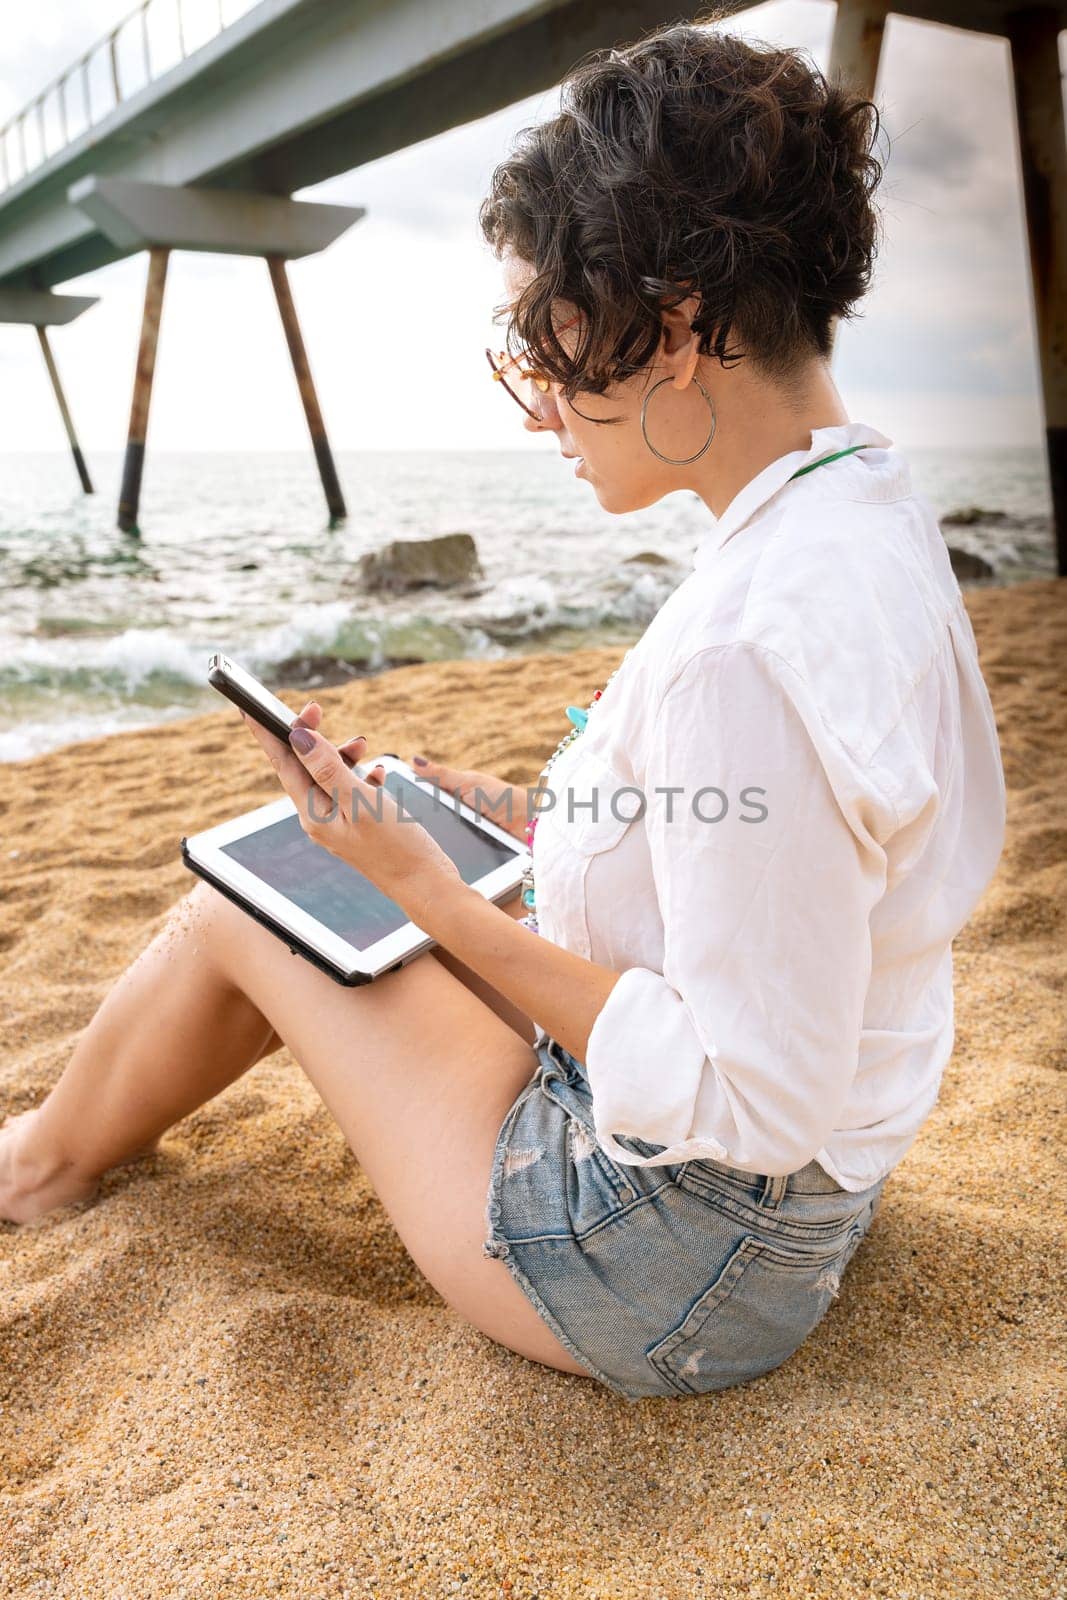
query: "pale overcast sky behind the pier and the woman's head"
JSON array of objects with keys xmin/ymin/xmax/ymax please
[{"xmin": 0, "ymin": 0, "xmax": 1062, "ymax": 451}]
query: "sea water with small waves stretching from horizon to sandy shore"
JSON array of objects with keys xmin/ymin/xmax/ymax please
[{"xmin": 0, "ymin": 450, "xmax": 1056, "ymax": 762}]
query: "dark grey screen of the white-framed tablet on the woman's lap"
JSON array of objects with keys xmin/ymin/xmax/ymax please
[{"xmin": 219, "ymin": 771, "xmax": 518, "ymax": 950}]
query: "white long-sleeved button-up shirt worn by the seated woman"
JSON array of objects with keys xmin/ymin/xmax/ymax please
[{"xmin": 533, "ymin": 422, "xmax": 1005, "ymax": 1190}]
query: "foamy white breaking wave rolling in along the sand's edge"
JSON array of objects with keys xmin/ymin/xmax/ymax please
[{"xmin": 0, "ymin": 555, "xmax": 685, "ymax": 762}]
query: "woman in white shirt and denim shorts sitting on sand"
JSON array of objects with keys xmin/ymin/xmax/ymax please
[{"xmin": 0, "ymin": 15, "xmax": 1005, "ymax": 1398}]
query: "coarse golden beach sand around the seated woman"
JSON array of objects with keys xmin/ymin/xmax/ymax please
[{"xmin": 0, "ymin": 579, "xmax": 1067, "ymax": 1600}]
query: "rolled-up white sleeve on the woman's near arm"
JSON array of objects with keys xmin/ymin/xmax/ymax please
[{"xmin": 585, "ymin": 640, "xmax": 888, "ymax": 1174}]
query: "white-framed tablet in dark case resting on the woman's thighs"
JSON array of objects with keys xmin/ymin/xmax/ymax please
[{"xmin": 181, "ymin": 755, "xmax": 530, "ymax": 984}]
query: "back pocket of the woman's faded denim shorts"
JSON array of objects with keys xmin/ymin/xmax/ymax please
[{"xmin": 646, "ymin": 1222, "xmax": 865, "ymax": 1395}]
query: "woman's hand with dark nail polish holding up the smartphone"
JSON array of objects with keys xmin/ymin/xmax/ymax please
[{"xmin": 242, "ymin": 701, "xmax": 461, "ymax": 925}]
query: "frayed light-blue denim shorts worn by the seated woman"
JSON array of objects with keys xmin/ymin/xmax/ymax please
[{"xmin": 482, "ymin": 1038, "xmax": 885, "ymax": 1400}]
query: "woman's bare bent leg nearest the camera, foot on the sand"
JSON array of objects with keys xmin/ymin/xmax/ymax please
[{"xmin": 0, "ymin": 883, "xmax": 585, "ymax": 1373}]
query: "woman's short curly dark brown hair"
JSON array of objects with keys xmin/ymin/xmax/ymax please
[{"xmin": 478, "ymin": 5, "xmax": 883, "ymax": 421}]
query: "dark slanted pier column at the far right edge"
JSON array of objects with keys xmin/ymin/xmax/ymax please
[{"xmin": 1005, "ymin": 6, "xmax": 1067, "ymax": 578}]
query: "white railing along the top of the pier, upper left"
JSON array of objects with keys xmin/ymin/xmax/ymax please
[{"xmin": 0, "ymin": 0, "xmax": 258, "ymax": 194}]
